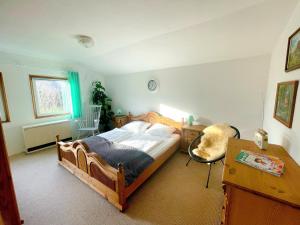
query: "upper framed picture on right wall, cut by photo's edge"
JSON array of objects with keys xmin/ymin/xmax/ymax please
[{"xmin": 285, "ymin": 28, "xmax": 300, "ymax": 72}]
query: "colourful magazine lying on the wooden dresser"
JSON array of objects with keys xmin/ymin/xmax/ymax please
[{"xmin": 235, "ymin": 150, "xmax": 284, "ymax": 176}]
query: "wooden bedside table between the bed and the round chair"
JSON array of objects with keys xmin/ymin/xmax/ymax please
[{"xmin": 181, "ymin": 125, "xmax": 206, "ymax": 154}]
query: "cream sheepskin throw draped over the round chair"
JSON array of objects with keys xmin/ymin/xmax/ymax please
[{"xmin": 193, "ymin": 124, "xmax": 235, "ymax": 160}]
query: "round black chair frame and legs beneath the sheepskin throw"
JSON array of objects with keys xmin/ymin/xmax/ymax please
[{"xmin": 186, "ymin": 126, "xmax": 241, "ymax": 188}]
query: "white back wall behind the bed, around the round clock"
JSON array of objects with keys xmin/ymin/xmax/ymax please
[{"xmin": 105, "ymin": 55, "xmax": 269, "ymax": 139}]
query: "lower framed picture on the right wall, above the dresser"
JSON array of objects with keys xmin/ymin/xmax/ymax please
[{"xmin": 274, "ymin": 81, "xmax": 299, "ymax": 128}]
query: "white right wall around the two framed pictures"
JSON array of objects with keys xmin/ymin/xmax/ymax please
[{"xmin": 264, "ymin": 3, "xmax": 300, "ymax": 165}]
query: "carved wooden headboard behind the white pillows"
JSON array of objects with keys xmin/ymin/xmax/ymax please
[{"xmin": 128, "ymin": 112, "xmax": 183, "ymax": 134}]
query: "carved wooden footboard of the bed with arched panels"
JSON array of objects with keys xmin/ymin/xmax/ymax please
[{"xmin": 56, "ymin": 136, "xmax": 127, "ymax": 211}]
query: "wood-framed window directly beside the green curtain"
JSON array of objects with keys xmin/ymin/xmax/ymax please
[{"xmin": 29, "ymin": 75, "xmax": 72, "ymax": 118}]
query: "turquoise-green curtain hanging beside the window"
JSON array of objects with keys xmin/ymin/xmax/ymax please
[{"xmin": 68, "ymin": 71, "xmax": 82, "ymax": 119}]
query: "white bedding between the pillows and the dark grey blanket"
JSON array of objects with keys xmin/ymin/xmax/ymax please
[{"xmin": 98, "ymin": 128, "xmax": 180, "ymax": 159}]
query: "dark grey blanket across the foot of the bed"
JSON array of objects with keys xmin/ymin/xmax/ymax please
[{"xmin": 83, "ymin": 136, "xmax": 154, "ymax": 186}]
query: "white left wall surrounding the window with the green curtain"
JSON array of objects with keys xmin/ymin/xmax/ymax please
[{"xmin": 0, "ymin": 53, "xmax": 103, "ymax": 155}]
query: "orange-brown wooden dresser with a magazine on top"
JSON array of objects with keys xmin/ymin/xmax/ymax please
[{"xmin": 221, "ymin": 139, "xmax": 300, "ymax": 225}]
